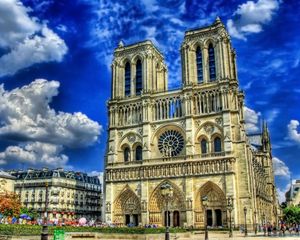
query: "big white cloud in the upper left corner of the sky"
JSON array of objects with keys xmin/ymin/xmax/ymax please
[{"xmin": 0, "ymin": 0, "xmax": 68, "ymax": 77}]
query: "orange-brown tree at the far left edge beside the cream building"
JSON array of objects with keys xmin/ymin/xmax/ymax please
[{"xmin": 0, "ymin": 193, "xmax": 21, "ymax": 217}]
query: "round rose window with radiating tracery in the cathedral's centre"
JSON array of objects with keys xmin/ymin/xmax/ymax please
[{"xmin": 158, "ymin": 130, "xmax": 184, "ymax": 157}]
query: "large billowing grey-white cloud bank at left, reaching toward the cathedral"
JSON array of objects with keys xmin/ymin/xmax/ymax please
[{"xmin": 0, "ymin": 79, "xmax": 102, "ymax": 165}]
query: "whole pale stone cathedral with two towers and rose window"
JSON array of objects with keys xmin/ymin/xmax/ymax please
[{"xmin": 105, "ymin": 18, "xmax": 276, "ymax": 227}]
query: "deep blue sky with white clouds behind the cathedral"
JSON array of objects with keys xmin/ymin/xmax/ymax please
[{"xmin": 0, "ymin": 0, "xmax": 300, "ymax": 202}]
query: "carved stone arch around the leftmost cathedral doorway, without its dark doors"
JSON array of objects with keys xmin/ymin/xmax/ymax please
[{"xmin": 113, "ymin": 185, "xmax": 141, "ymax": 225}]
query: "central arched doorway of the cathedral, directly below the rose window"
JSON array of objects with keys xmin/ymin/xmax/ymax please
[{"xmin": 149, "ymin": 180, "xmax": 186, "ymax": 226}]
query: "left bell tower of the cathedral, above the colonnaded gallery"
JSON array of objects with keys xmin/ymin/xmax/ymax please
[{"xmin": 111, "ymin": 40, "xmax": 168, "ymax": 99}]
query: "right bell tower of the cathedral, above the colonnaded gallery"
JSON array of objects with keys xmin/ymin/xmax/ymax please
[{"xmin": 181, "ymin": 18, "xmax": 237, "ymax": 86}]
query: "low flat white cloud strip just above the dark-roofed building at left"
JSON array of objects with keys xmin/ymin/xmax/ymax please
[{"xmin": 0, "ymin": 142, "xmax": 68, "ymax": 167}]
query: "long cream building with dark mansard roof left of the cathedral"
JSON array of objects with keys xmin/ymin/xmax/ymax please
[{"xmin": 9, "ymin": 168, "xmax": 102, "ymax": 220}]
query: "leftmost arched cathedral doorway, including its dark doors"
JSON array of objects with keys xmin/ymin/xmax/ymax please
[{"xmin": 113, "ymin": 186, "xmax": 141, "ymax": 226}]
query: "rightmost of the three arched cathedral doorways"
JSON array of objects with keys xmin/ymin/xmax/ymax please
[{"xmin": 195, "ymin": 181, "xmax": 226, "ymax": 227}]
